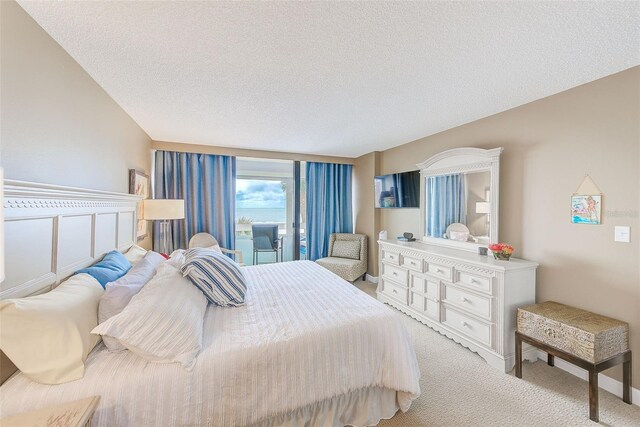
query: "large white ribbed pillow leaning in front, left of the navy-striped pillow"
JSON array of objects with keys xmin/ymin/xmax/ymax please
[{"xmin": 91, "ymin": 263, "xmax": 207, "ymax": 369}]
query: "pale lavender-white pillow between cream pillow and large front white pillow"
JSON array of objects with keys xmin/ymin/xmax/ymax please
[{"xmin": 98, "ymin": 251, "xmax": 165, "ymax": 351}]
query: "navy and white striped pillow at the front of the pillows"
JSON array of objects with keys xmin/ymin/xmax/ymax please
[{"xmin": 181, "ymin": 248, "xmax": 247, "ymax": 306}]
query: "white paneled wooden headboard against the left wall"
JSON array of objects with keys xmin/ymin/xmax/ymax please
[{"xmin": 0, "ymin": 180, "xmax": 140, "ymax": 299}]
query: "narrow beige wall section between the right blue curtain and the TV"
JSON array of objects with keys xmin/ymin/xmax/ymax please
[{"xmin": 352, "ymin": 151, "xmax": 381, "ymax": 276}]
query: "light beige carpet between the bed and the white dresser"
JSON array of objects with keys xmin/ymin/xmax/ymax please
[{"xmin": 354, "ymin": 281, "xmax": 640, "ymax": 427}]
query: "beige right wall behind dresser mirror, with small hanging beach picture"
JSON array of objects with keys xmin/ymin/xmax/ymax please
[{"xmin": 356, "ymin": 67, "xmax": 640, "ymax": 387}]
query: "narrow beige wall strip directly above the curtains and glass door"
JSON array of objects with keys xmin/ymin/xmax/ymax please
[{"xmin": 151, "ymin": 141, "xmax": 354, "ymax": 164}]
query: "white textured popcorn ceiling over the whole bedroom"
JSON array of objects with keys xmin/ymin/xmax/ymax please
[{"xmin": 19, "ymin": 1, "xmax": 640, "ymax": 156}]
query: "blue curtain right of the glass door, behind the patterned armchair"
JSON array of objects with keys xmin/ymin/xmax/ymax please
[{"xmin": 305, "ymin": 162, "xmax": 353, "ymax": 261}]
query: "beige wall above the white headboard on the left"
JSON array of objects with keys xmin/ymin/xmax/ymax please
[{"xmin": 0, "ymin": 1, "xmax": 151, "ymax": 246}]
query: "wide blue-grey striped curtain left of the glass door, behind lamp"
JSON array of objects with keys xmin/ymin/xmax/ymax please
[{"xmin": 153, "ymin": 151, "xmax": 236, "ymax": 254}]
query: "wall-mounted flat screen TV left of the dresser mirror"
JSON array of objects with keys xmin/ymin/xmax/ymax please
[{"xmin": 374, "ymin": 171, "xmax": 420, "ymax": 208}]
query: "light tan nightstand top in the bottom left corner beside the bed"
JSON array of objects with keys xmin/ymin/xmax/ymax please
[{"xmin": 0, "ymin": 396, "xmax": 100, "ymax": 427}]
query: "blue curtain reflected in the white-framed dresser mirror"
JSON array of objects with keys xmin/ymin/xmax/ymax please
[{"xmin": 426, "ymin": 174, "xmax": 467, "ymax": 241}]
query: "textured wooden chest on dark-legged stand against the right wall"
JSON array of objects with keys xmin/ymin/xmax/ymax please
[{"xmin": 515, "ymin": 301, "xmax": 631, "ymax": 422}]
